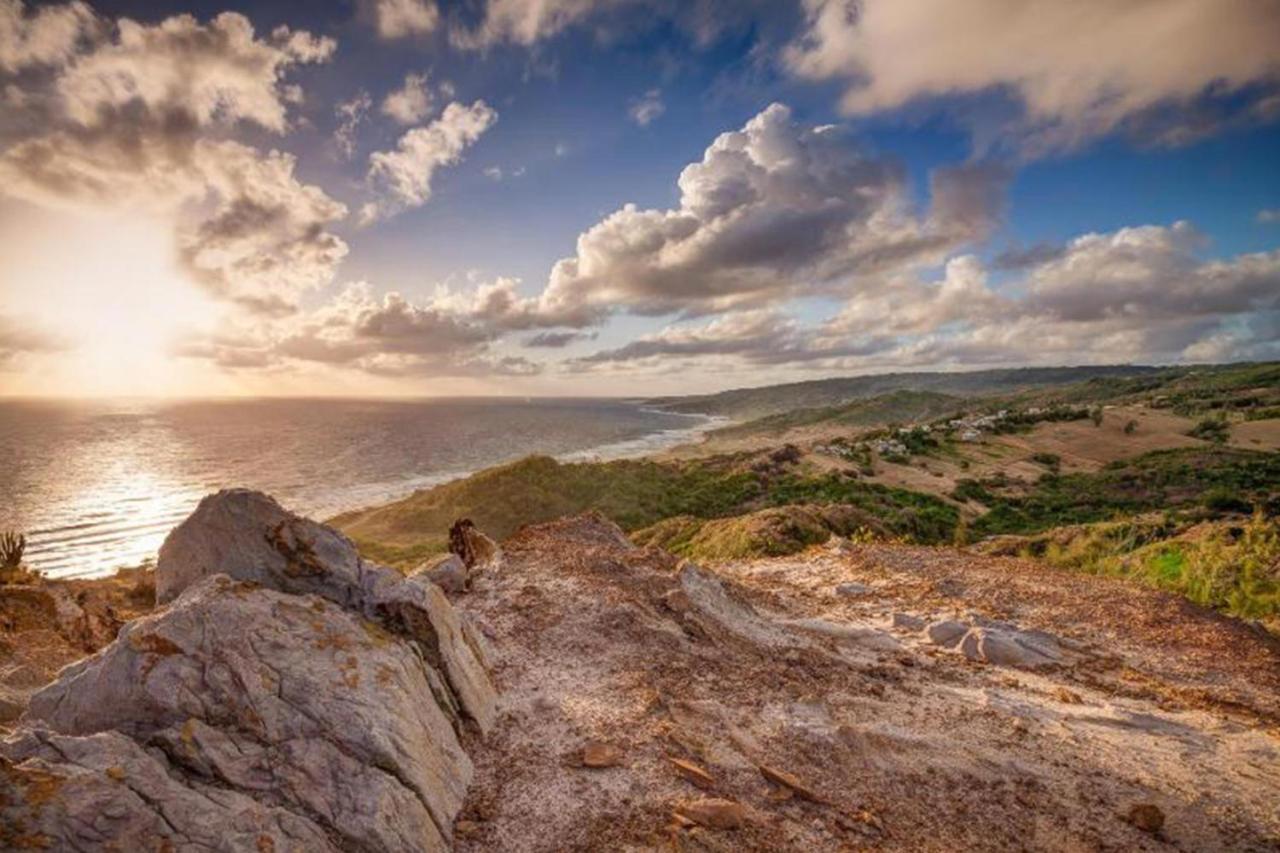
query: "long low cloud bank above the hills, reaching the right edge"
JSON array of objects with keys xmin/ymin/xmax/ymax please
[{"xmin": 573, "ymin": 223, "xmax": 1280, "ymax": 370}]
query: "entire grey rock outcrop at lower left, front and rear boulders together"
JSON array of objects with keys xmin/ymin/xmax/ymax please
[{"xmin": 0, "ymin": 491, "xmax": 494, "ymax": 850}]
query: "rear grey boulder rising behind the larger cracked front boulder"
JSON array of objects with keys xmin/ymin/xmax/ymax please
[{"xmin": 156, "ymin": 489, "xmax": 497, "ymax": 731}]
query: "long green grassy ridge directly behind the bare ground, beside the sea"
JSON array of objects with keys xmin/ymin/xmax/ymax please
[{"xmin": 333, "ymin": 456, "xmax": 957, "ymax": 565}]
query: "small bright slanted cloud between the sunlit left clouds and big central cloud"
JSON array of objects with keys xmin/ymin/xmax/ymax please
[{"xmin": 361, "ymin": 101, "xmax": 498, "ymax": 223}]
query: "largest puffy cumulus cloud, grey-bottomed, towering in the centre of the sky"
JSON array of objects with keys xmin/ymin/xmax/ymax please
[{"xmin": 543, "ymin": 104, "xmax": 1007, "ymax": 315}]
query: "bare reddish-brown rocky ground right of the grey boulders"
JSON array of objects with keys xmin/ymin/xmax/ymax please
[{"xmin": 456, "ymin": 519, "xmax": 1280, "ymax": 850}]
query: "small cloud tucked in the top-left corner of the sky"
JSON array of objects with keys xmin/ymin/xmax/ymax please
[{"xmin": 0, "ymin": 0, "xmax": 101, "ymax": 73}]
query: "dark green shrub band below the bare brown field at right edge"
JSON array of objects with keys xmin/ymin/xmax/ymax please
[{"xmin": 956, "ymin": 447, "xmax": 1280, "ymax": 535}]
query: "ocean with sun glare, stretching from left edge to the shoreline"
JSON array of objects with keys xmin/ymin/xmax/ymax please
[{"xmin": 0, "ymin": 398, "xmax": 714, "ymax": 578}]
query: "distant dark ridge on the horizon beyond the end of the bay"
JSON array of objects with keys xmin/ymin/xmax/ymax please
[{"xmin": 649, "ymin": 365, "xmax": 1184, "ymax": 420}]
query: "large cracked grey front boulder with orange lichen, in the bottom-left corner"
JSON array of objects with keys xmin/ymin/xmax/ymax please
[{"xmin": 0, "ymin": 575, "xmax": 472, "ymax": 850}]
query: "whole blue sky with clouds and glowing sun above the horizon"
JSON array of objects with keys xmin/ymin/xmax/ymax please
[{"xmin": 0, "ymin": 0, "xmax": 1280, "ymax": 397}]
